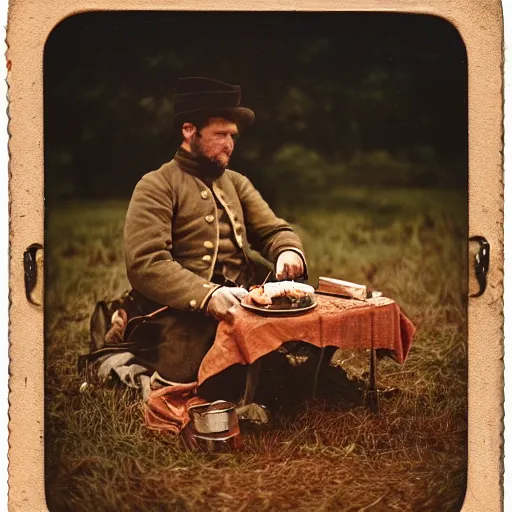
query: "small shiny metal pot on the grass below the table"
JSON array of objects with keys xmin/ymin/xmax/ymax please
[{"xmin": 189, "ymin": 400, "xmax": 238, "ymax": 434}]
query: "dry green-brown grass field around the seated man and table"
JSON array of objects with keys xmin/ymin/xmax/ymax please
[{"xmin": 45, "ymin": 190, "xmax": 467, "ymax": 512}]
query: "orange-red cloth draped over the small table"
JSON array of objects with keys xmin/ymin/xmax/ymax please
[{"xmin": 199, "ymin": 295, "xmax": 415, "ymax": 385}]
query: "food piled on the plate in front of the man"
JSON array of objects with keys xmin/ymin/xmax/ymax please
[{"xmin": 244, "ymin": 281, "xmax": 315, "ymax": 309}]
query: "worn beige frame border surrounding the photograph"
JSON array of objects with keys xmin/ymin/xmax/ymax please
[{"xmin": 7, "ymin": 0, "xmax": 504, "ymax": 512}]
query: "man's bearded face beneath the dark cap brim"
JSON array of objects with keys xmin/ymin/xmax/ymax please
[{"xmin": 190, "ymin": 117, "xmax": 238, "ymax": 168}]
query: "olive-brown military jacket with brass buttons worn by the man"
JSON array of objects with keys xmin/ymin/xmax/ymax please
[{"xmin": 124, "ymin": 150, "xmax": 303, "ymax": 311}]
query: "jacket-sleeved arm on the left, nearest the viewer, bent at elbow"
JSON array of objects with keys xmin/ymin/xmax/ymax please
[{"xmin": 124, "ymin": 172, "xmax": 218, "ymax": 310}]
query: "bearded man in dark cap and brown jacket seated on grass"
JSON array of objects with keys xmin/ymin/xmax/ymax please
[{"xmin": 124, "ymin": 78, "xmax": 307, "ymax": 382}]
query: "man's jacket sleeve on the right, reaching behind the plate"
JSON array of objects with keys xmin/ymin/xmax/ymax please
[{"xmin": 232, "ymin": 173, "xmax": 307, "ymax": 278}]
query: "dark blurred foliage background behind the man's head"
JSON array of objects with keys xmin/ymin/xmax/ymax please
[{"xmin": 44, "ymin": 12, "xmax": 467, "ymax": 205}]
